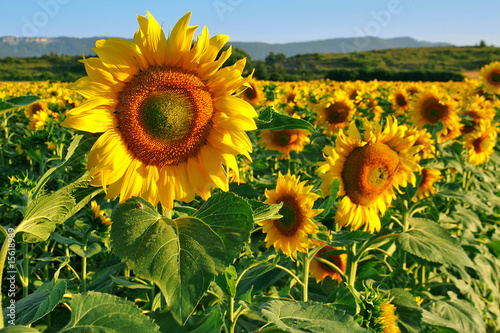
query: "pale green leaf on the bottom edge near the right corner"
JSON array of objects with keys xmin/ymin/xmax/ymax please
[{"xmin": 422, "ymin": 298, "xmax": 486, "ymax": 333}]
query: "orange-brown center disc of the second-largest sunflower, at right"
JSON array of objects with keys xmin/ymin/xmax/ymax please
[{"xmin": 342, "ymin": 142, "xmax": 399, "ymax": 206}]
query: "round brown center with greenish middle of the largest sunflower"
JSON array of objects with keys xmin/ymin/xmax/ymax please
[{"xmin": 115, "ymin": 66, "xmax": 214, "ymax": 167}]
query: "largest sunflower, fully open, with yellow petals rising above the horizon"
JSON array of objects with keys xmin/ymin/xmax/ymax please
[{"xmin": 63, "ymin": 13, "xmax": 257, "ymax": 210}]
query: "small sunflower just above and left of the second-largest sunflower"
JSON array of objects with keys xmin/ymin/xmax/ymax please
[{"xmin": 315, "ymin": 90, "xmax": 356, "ymax": 135}]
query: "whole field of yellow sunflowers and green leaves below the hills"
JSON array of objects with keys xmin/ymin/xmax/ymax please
[{"xmin": 0, "ymin": 13, "xmax": 500, "ymax": 333}]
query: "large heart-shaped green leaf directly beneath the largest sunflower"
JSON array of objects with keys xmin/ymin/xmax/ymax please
[{"xmin": 111, "ymin": 192, "xmax": 253, "ymax": 323}]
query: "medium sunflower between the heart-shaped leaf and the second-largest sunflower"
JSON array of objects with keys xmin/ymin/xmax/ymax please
[{"xmin": 258, "ymin": 172, "xmax": 323, "ymax": 258}]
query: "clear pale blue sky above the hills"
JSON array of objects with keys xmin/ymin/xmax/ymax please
[{"xmin": 0, "ymin": 0, "xmax": 500, "ymax": 46}]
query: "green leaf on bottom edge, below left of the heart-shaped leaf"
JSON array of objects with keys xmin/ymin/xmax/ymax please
[{"xmin": 59, "ymin": 291, "xmax": 160, "ymax": 333}]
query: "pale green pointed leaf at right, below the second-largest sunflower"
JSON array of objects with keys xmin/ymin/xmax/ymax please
[{"xmin": 396, "ymin": 218, "xmax": 473, "ymax": 267}]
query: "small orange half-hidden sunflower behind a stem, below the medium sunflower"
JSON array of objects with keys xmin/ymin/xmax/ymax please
[{"xmin": 309, "ymin": 245, "xmax": 347, "ymax": 283}]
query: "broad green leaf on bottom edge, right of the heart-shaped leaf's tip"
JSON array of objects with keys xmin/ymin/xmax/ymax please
[{"xmin": 261, "ymin": 301, "xmax": 368, "ymax": 333}]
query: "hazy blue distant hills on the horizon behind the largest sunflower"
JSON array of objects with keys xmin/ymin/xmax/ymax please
[{"xmin": 0, "ymin": 36, "xmax": 451, "ymax": 60}]
